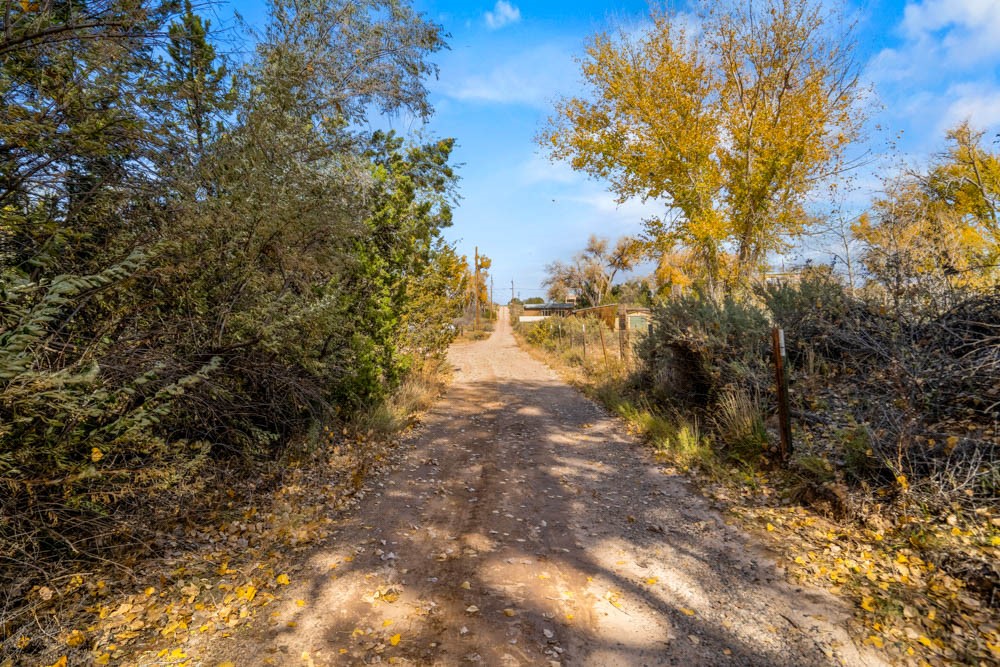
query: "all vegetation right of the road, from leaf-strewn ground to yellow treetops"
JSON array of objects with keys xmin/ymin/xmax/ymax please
[{"xmin": 518, "ymin": 0, "xmax": 1000, "ymax": 665}]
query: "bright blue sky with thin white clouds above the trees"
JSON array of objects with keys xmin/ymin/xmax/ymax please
[{"xmin": 213, "ymin": 0, "xmax": 1000, "ymax": 302}]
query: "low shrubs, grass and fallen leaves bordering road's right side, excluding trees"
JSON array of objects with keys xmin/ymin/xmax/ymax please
[{"xmin": 518, "ymin": 269, "xmax": 1000, "ymax": 664}]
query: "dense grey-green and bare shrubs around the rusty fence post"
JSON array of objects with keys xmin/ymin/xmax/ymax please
[{"xmin": 636, "ymin": 276, "xmax": 1000, "ymax": 499}]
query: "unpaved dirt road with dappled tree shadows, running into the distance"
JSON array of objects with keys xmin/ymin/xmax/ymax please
[{"xmin": 214, "ymin": 312, "xmax": 881, "ymax": 666}]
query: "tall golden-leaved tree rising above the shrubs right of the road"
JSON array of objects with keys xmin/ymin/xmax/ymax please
[{"xmin": 538, "ymin": 0, "xmax": 863, "ymax": 289}]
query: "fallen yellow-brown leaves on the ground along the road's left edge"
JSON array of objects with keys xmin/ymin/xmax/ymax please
[{"xmin": 7, "ymin": 428, "xmax": 402, "ymax": 667}]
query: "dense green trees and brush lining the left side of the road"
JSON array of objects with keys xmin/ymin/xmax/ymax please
[{"xmin": 0, "ymin": 0, "xmax": 470, "ymax": 665}]
